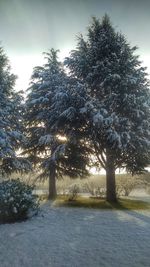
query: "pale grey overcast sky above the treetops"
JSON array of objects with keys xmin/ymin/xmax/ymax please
[{"xmin": 0, "ymin": 0, "xmax": 150, "ymax": 90}]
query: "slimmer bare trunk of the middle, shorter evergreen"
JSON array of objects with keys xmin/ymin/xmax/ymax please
[{"xmin": 48, "ymin": 164, "xmax": 57, "ymax": 199}]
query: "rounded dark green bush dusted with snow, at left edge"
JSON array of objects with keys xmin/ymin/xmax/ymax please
[{"xmin": 0, "ymin": 179, "xmax": 38, "ymax": 223}]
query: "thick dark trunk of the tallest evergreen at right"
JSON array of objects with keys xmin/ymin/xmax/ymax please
[{"xmin": 106, "ymin": 150, "xmax": 117, "ymax": 202}]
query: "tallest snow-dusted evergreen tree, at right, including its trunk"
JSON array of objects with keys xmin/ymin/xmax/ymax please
[{"xmin": 65, "ymin": 15, "xmax": 150, "ymax": 201}]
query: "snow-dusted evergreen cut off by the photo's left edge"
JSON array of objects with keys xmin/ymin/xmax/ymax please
[{"xmin": 0, "ymin": 47, "xmax": 30, "ymax": 174}]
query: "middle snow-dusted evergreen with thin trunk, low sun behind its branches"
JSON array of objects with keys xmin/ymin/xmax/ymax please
[{"xmin": 25, "ymin": 49, "xmax": 88, "ymax": 198}]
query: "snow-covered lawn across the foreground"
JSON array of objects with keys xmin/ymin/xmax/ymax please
[{"xmin": 0, "ymin": 203, "xmax": 150, "ymax": 267}]
